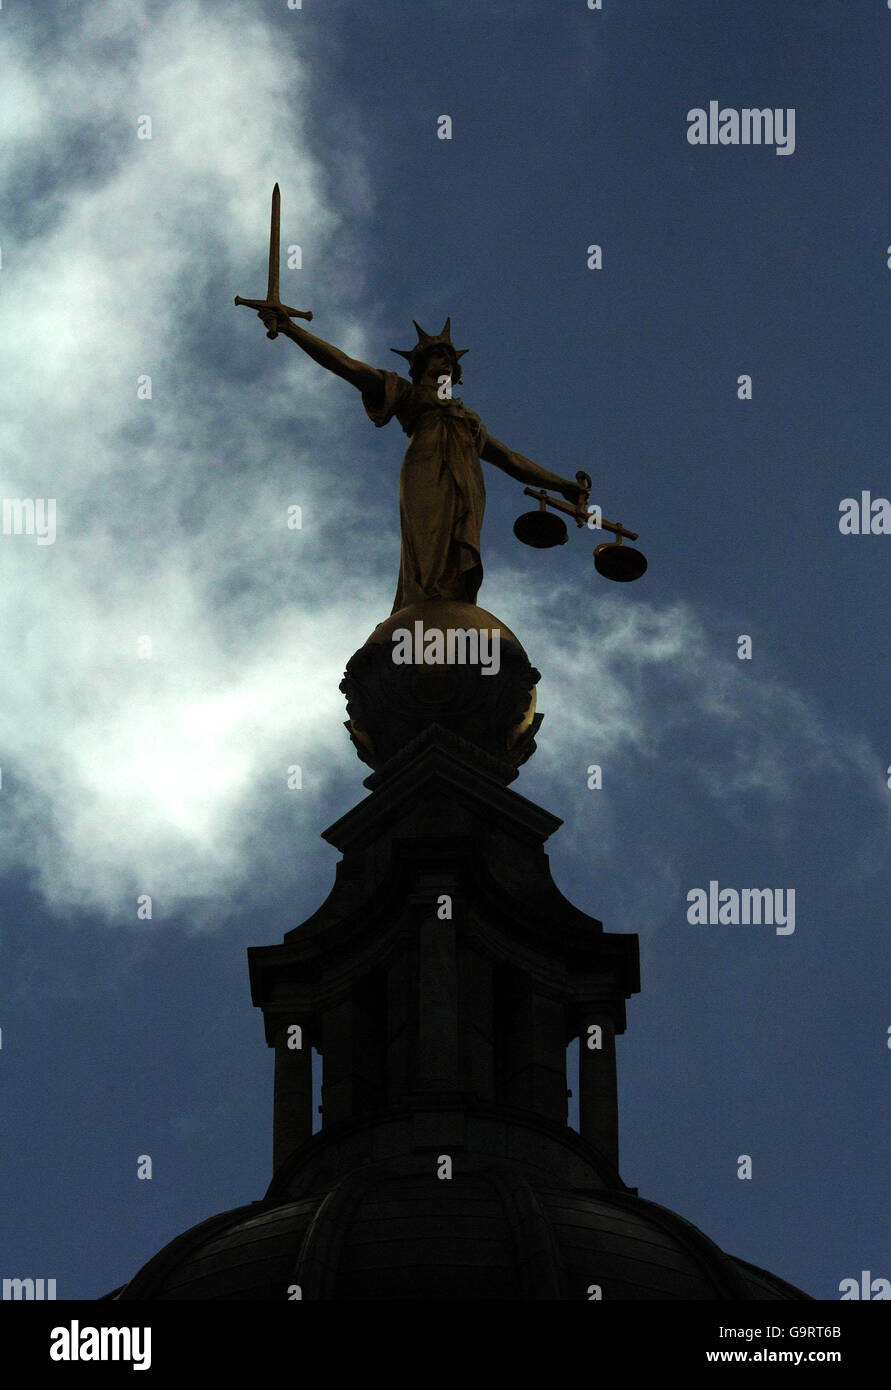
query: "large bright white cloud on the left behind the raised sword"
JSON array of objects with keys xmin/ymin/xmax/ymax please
[{"xmin": 0, "ymin": 3, "xmax": 385, "ymax": 920}]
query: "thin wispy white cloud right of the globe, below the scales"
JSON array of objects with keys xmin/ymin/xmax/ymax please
[{"xmin": 503, "ymin": 569, "xmax": 865, "ymax": 798}]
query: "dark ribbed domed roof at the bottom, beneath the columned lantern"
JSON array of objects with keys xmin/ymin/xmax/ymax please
[{"xmin": 106, "ymin": 1166, "xmax": 808, "ymax": 1300}]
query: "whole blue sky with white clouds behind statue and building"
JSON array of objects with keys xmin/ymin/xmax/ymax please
[{"xmin": 0, "ymin": 0, "xmax": 891, "ymax": 1298}]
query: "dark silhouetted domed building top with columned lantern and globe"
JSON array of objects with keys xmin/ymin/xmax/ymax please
[{"xmin": 110, "ymin": 600, "xmax": 808, "ymax": 1301}]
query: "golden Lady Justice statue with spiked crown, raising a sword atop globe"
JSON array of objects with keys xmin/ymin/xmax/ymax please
[{"xmin": 235, "ymin": 183, "xmax": 635, "ymax": 613}]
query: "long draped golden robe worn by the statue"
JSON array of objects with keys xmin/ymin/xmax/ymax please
[{"xmin": 363, "ymin": 371, "xmax": 487, "ymax": 613}]
